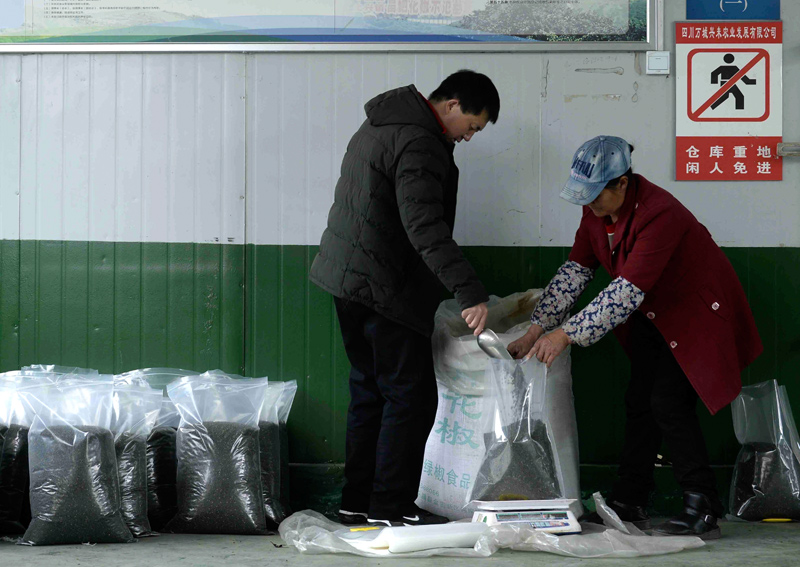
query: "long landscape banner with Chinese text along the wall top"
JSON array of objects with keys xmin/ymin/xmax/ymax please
[{"xmin": 0, "ymin": 0, "xmax": 652, "ymax": 44}]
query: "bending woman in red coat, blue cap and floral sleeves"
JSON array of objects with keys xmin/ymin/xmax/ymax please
[{"xmin": 508, "ymin": 136, "xmax": 762, "ymax": 539}]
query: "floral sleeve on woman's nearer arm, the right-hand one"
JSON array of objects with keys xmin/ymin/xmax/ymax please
[{"xmin": 562, "ymin": 277, "xmax": 644, "ymax": 346}]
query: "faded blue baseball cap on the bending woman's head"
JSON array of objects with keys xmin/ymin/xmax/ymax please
[{"xmin": 561, "ymin": 136, "xmax": 631, "ymax": 205}]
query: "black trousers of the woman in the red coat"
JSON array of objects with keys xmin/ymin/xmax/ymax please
[{"xmin": 612, "ymin": 311, "xmax": 722, "ymax": 515}]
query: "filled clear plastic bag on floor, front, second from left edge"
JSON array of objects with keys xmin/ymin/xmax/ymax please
[{"xmin": 19, "ymin": 377, "xmax": 134, "ymax": 545}]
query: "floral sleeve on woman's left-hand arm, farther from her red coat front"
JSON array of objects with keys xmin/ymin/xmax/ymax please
[{"xmin": 531, "ymin": 260, "xmax": 594, "ymax": 331}]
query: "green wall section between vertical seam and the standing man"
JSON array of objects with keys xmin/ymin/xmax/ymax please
[{"xmin": 246, "ymin": 246, "xmax": 349, "ymax": 463}]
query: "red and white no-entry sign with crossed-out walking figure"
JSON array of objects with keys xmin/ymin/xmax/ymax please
[{"xmin": 675, "ymin": 21, "xmax": 783, "ymax": 181}]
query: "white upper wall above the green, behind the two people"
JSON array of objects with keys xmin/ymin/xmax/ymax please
[{"xmin": 0, "ymin": 3, "xmax": 800, "ymax": 246}]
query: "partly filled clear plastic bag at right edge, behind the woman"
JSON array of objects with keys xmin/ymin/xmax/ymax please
[{"xmin": 730, "ymin": 380, "xmax": 800, "ymax": 521}]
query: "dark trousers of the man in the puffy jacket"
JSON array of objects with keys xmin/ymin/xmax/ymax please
[{"xmin": 334, "ymin": 297, "xmax": 438, "ymax": 519}]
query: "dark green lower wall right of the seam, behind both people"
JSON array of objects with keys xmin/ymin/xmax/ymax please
[{"xmin": 247, "ymin": 246, "xmax": 800, "ymax": 465}]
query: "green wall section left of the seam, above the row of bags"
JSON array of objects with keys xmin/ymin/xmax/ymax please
[{"xmin": 0, "ymin": 241, "xmax": 245, "ymax": 373}]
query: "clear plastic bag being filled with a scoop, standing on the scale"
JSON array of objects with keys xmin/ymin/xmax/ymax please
[{"xmin": 469, "ymin": 359, "xmax": 565, "ymax": 501}]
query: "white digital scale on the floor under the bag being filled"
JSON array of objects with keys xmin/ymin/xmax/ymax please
[{"xmin": 471, "ymin": 499, "xmax": 581, "ymax": 535}]
